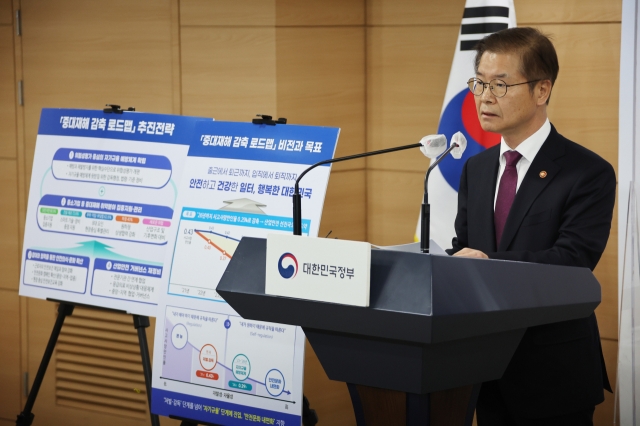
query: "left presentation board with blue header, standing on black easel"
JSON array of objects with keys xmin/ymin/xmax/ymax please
[{"xmin": 20, "ymin": 109, "xmax": 203, "ymax": 316}]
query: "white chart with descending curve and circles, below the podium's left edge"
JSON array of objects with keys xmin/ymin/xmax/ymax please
[{"xmin": 162, "ymin": 306, "xmax": 298, "ymax": 403}]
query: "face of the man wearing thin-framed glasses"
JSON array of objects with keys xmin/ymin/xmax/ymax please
[{"xmin": 475, "ymin": 51, "xmax": 537, "ymax": 140}]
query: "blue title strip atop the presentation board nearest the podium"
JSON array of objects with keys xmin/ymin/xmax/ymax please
[{"xmin": 189, "ymin": 121, "xmax": 340, "ymax": 165}]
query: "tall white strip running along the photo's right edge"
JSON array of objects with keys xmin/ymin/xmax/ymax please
[{"xmin": 620, "ymin": 0, "xmax": 640, "ymax": 426}]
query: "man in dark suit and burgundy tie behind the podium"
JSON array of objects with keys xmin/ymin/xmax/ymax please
[{"xmin": 449, "ymin": 28, "xmax": 616, "ymax": 426}]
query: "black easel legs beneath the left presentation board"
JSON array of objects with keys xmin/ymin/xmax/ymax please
[{"xmin": 16, "ymin": 299, "xmax": 160, "ymax": 426}]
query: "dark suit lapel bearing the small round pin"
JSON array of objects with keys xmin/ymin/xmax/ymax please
[{"xmin": 494, "ymin": 126, "xmax": 564, "ymax": 251}]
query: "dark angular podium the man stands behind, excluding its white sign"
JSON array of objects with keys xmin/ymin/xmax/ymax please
[{"xmin": 217, "ymin": 237, "xmax": 601, "ymax": 426}]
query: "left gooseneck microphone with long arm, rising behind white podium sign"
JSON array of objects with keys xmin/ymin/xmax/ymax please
[{"xmin": 293, "ymin": 135, "xmax": 448, "ymax": 235}]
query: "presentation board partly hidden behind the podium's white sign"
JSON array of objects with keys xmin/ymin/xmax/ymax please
[{"xmin": 152, "ymin": 122, "xmax": 339, "ymax": 426}]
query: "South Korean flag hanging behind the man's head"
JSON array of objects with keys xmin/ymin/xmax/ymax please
[{"xmin": 414, "ymin": 0, "xmax": 516, "ymax": 248}]
